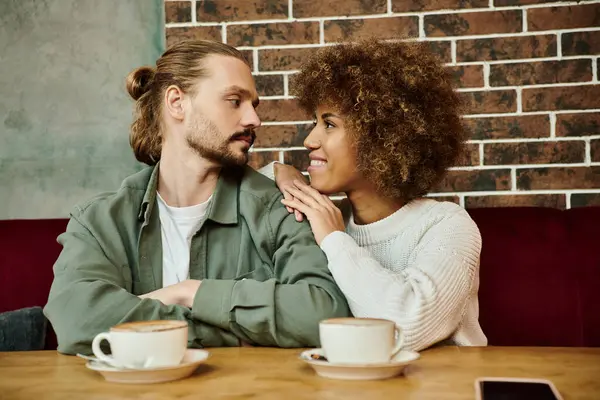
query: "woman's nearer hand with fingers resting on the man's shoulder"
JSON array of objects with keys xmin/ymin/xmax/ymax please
[{"xmin": 281, "ymin": 180, "xmax": 345, "ymax": 245}]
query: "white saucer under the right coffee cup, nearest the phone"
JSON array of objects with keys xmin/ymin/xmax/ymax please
[{"xmin": 300, "ymin": 349, "xmax": 420, "ymax": 380}]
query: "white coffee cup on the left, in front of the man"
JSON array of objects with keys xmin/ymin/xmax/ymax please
[{"xmin": 92, "ymin": 321, "xmax": 188, "ymax": 369}]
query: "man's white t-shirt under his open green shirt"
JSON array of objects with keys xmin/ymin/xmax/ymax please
[{"xmin": 156, "ymin": 192, "xmax": 212, "ymax": 287}]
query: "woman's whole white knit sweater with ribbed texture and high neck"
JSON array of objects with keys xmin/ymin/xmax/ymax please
[{"xmin": 321, "ymin": 199, "xmax": 487, "ymax": 351}]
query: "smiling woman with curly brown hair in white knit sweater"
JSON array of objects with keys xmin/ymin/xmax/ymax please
[{"xmin": 264, "ymin": 40, "xmax": 487, "ymax": 350}]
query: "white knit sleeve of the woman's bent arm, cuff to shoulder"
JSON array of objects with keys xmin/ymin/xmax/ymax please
[{"xmin": 321, "ymin": 213, "xmax": 481, "ymax": 351}]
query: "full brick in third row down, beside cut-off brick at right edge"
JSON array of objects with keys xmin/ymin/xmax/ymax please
[{"xmin": 456, "ymin": 35, "xmax": 557, "ymax": 62}]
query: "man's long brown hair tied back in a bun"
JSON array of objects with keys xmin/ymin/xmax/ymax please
[{"xmin": 126, "ymin": 40, "xmax": 247, "ymax": 165}]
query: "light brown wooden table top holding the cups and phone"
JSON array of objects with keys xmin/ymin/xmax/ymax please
[{"xmin": 0, "ymin": 347, "xmax": 600, "ymax": 400}]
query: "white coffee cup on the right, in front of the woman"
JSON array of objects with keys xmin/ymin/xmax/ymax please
[{"xmin": 319, "ymin": 318, "xmax": 404, "ymax": 364}]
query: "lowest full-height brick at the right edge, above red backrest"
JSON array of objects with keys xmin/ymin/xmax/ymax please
[{"xmin": 517, "ymin": 167, "xmax": 600, "ymax": 190}]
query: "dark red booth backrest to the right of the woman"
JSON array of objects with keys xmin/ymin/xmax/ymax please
[{"xmin": 469, "ymin": 207, "xmax": 600, "ymax": 346}]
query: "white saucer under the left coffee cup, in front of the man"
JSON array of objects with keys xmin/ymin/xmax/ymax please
[{"xmin": 85, "ymin": 349, "xmax": 210, "ymax": 383}]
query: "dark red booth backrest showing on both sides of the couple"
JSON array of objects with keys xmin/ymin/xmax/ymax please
[{"xmin": 0, "ymin": 207, "xmax": 600, "ymax": 349}]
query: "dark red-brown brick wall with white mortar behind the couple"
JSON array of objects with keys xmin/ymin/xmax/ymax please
[{"xmin": 165, "ymin": 0, "xmax": 600, "ymax": 208}]
